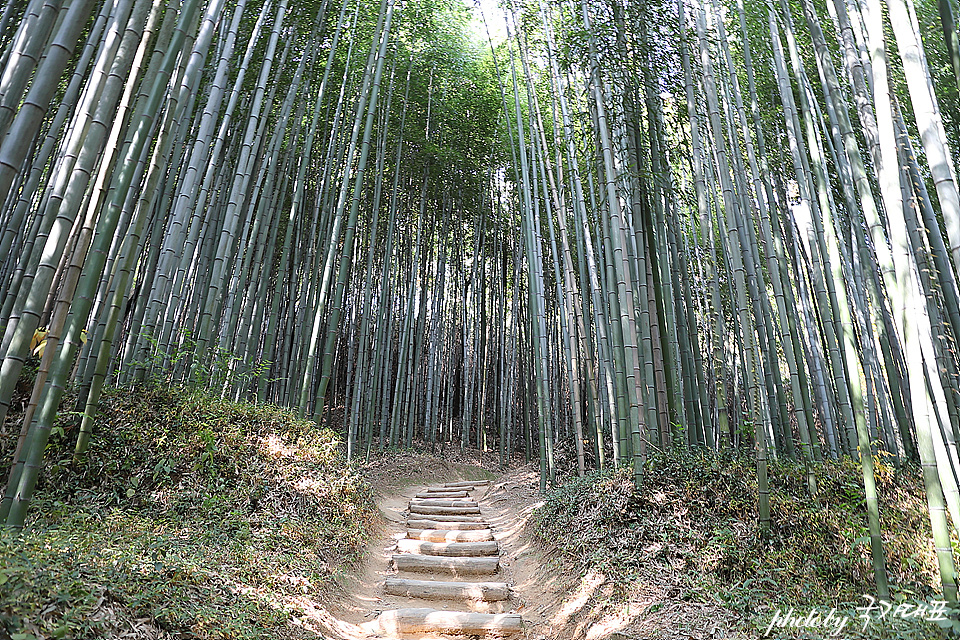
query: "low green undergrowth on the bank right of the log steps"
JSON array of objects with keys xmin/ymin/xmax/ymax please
[{"xmin": 533, "ymin": 452, "xmax": 942, "ymax": 640}]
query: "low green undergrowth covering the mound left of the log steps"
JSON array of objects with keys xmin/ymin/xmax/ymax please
[{"xmin": 0, "ymin": 388, "xmax": 375, "ymax": 640}]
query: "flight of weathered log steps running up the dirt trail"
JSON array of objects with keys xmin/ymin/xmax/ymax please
[{"xmin": 362, "ymin": 480, "xmax": 523, "ymax": 638}]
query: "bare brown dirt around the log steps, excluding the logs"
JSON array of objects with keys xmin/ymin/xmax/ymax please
[{"xmin": 301, "ymin": 459, "xmax": 744, "ymax": 640}]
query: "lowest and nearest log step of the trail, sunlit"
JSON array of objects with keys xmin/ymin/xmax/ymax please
[{"xmin": 361, "ymin": 609, "xmax": 523, "ymax": 635}]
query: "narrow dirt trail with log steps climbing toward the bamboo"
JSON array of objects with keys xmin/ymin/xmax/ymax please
[{"xmin": 308, "ymin": 470, "xmax": 584, "ymax": 640}]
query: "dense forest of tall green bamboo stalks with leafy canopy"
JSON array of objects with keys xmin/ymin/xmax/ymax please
[{"xmin": 0, "ymin": 0, "xmax": 960, "ymax": 638}]
